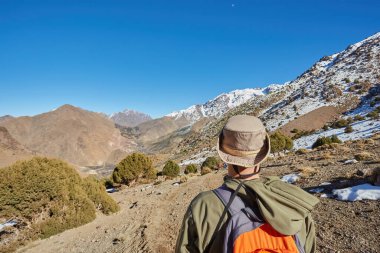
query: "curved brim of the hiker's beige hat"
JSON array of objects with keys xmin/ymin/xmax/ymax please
[{"xmin": 216, "ymin": 133, "xmax": 270, "ymax": 168}]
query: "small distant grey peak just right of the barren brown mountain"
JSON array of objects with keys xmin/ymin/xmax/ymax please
[{"xmin": 109, "ymin": 109, "xmax": 152, "ymax": 127}]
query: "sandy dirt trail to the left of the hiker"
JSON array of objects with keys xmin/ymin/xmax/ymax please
[{"xmin": 17, "ymin": 173, "xmax": 222, "ymax": 253}]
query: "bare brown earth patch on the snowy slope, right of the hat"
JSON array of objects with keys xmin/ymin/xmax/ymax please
[{"xmin": 280, "ymin": 106, "xmax": 341, "ymax": 136}]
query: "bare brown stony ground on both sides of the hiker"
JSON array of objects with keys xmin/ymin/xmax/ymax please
[{"xmin": 11, "ymin": 136, "xmax": 380, "ymax": 253}]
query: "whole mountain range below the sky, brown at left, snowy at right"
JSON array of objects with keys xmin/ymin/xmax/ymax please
[{"xmin": 0, "ymin": 33, "xmax": 380, "ymax": 169}]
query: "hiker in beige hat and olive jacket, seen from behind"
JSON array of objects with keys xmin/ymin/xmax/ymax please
[{"xmin": 176, "ymin": 115, "xmax": 318, "ymax": 253}]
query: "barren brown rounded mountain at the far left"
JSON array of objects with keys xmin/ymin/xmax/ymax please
[{"xmin": 0, "ymin": 105, "xmax": 128, "ymax": 166}]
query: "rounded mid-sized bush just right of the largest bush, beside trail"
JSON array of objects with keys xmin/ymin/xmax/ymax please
[{"xmin": 112, "ymin": 153, "xmax": 156, "ymax": 185}]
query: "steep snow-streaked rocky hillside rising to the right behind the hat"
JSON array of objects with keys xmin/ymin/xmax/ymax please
[{"xmin": 177, "ymin": 33, "xmax": 380, "ymax": 155}]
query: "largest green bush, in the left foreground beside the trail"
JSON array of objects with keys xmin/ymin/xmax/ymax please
[{"xmin": 0, "ymin": 157, "xmax": 118, "ymax": 250}]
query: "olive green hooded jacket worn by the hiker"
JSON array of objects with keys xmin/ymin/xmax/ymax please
[{"xmin": 175, "ymin": 177, "xmax": 319, "ymax": 253}]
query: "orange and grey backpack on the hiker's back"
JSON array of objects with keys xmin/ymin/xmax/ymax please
[{"xmin": 213, "ymin": 184, "xmax": 305, "ymax": 253}]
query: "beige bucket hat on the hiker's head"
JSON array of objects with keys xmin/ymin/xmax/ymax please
[{"xmin": 217, "ymin": 115, "xmax": 270, "ymax": 168}]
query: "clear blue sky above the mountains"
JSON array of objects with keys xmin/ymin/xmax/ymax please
[{"xmin": 0, "ymin": 0, "xmax": 380, "ymax": 117}]
